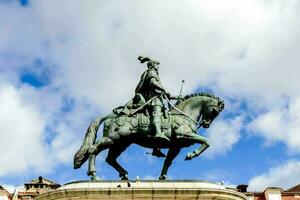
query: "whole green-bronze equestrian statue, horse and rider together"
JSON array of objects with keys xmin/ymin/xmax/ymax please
[{"xmin": 74, "ymin": 57, "xmax": 224, "ymax": 180}]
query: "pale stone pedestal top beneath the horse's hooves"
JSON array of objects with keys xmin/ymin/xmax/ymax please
[{"xmin": 36, "ymin": 181, "xmax": 246, "ymax": 200}]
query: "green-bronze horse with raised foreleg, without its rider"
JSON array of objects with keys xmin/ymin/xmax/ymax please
[{"xmin": 74, "ymin": 93, "xmax": 224, "ymax": 180}]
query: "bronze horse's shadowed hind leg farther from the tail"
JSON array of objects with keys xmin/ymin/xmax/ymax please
[{"xmin": 106, "ymin": 144, "xmax": 129, "ymax": 180}]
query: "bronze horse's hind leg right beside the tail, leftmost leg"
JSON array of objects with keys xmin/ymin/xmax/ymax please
[{"xmin": 87, "ymin": 137, "xmax": 113, "ymax": 180}]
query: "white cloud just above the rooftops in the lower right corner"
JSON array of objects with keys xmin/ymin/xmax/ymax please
[{"xmin": 248, "ymin": 160, "xmax": 300, "ymax": 191}]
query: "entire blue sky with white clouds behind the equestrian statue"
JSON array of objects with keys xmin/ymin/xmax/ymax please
[{"xmin": 0, "ymin": 0, "xmax": 300, "ymax": 191}]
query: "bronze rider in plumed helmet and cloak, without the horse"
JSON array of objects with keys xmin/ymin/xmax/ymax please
[{"xmin": 114, "ymin": 56, "xmax": 180, "ymax": 157}]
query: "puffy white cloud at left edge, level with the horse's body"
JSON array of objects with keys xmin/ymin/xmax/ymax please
[{"xmin": 0, "ymin": 84, "xmax": 53, "ymax": 176}]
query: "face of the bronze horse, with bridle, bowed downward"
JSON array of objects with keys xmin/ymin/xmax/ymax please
[{"xmin": 200, "ymin": 98, "xmax": 225, "ymax": 128}]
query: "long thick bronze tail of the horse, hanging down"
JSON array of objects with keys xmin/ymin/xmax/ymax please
[{"xmin": 73, "ymin": 115, "xmax": 110, "ymax": 169}]
